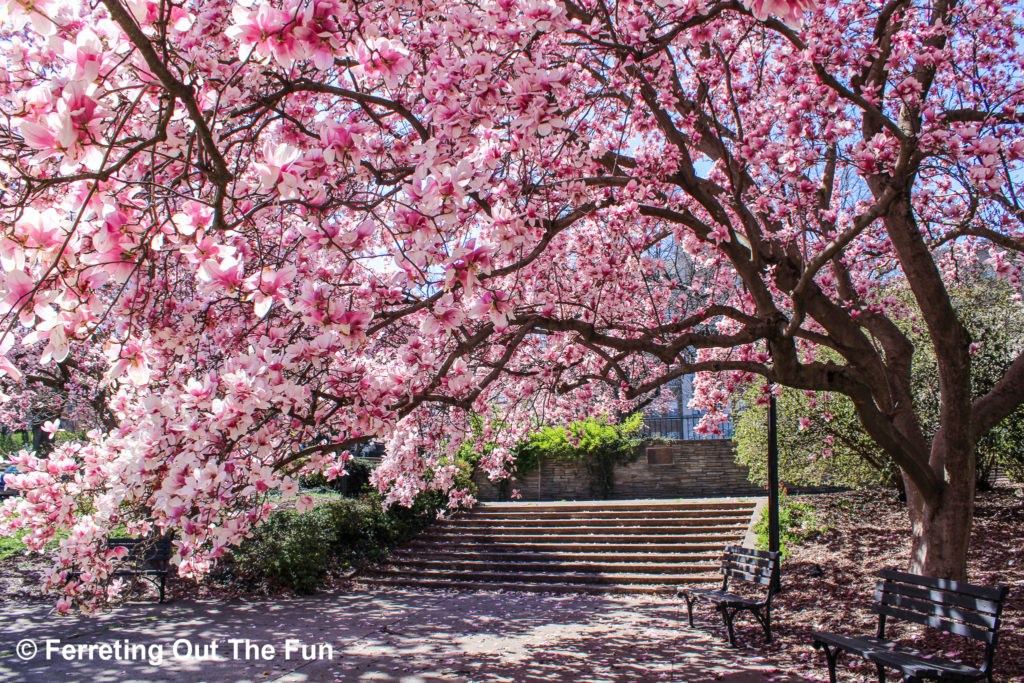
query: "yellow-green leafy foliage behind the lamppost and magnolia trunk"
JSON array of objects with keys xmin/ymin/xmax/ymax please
[{"xmin": 732, "ymin": 274, "xmax": 1024, "ymax": 487}]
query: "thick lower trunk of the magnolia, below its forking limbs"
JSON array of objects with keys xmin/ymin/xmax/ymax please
[{"xmin": 903, "ymin": 431, "xmax": 975, "ymax": 581}]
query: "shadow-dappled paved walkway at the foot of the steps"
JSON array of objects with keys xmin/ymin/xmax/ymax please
[{"xmin": 0, "ymin": 590, "xmax": 806, "ymax": 683}]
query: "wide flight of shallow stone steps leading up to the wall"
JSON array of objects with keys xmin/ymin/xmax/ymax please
[{"xmin": 359, "ymin": 499, "xmax": 757, "ymax": 593}]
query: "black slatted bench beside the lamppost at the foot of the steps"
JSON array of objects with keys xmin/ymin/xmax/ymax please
[{"xmin": 676, "ymin": 546, "xmax": 779, "ymax": 647}]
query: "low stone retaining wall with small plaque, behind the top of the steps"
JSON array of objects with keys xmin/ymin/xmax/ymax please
[{"xmin": 474, "ymin": 439, "xmax": 764, "ymax": 501}]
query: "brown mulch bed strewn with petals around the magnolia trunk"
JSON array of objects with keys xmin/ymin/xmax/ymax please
[{"xmin": 744, "ymin": 487, "xmax": 1024, "ymax": 681}]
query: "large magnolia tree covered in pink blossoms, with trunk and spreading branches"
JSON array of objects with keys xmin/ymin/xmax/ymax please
[{"xmin": 0, "ymin": 0, "xmax": 1024, "ymax": 606}]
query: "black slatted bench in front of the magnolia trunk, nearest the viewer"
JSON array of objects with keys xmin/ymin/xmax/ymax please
[{"xmin": 811, "ymin": 569, "xmax": 1007, "ymax": 683}]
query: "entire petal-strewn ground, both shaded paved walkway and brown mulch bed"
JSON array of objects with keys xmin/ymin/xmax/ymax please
[{"xmin": 0, "ymin": 488, "xmax": 1024, "ymax": 683}]
